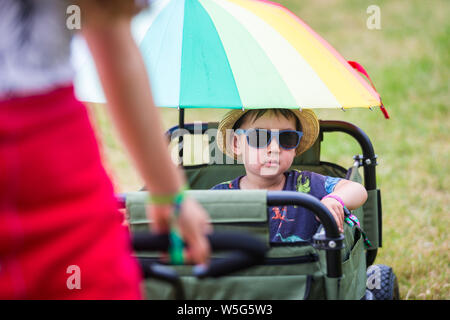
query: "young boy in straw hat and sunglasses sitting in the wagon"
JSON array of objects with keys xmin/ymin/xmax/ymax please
[{"xmin": 213, "ymin": 109, "xmax": 367, "ymax": 242}]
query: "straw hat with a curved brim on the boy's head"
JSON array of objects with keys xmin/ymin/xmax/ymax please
[{"xmin": 217, "ymin": 109, "xmax": 320, "ymax": 158}]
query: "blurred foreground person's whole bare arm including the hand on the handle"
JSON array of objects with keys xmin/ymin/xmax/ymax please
[{"xmin": 81, "ymin": 0, "xmax": 210, "ymax": 263}]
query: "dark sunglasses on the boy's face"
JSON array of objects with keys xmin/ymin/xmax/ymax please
[{"xmin": 235, "ymin": 129, "xmax": 303, "ymax": 150}]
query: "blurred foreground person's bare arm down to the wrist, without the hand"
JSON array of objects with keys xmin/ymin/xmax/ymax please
[{"xmin": 82, "ymin": 9, "xmax": 183, "ymax": 194}]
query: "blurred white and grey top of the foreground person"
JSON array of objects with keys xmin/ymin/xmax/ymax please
[{"xmin": 0, "ymin": 0, "xmax": 74, "ymax": 97}]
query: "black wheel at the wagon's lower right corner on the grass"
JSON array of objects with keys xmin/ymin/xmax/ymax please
[{"xmin": 366, "ymin": 264, "xmax": 400, "ymax": 300}]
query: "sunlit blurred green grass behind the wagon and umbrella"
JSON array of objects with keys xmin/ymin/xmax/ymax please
[{"xmin": 86, "ymin": 0, "xmax": 450, "ymax": 299}]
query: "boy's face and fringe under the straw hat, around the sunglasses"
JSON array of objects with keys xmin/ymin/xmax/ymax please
[{"xmin": 233, "ymin": 112, "xmax": 296, "ymax": 178}]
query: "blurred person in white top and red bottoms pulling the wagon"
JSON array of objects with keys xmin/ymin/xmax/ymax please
[{"xmin": 0, "ymin": 0, "xmax": 211, "ymax": 299}]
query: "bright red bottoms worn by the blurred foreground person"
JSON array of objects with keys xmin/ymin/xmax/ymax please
[{"xmin": 0, "ymin": 87, "xmax": 141, "ymax": 299}]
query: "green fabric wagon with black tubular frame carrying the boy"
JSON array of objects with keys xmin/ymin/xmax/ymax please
[{"xmin": 124, "ymin": 118, "xmax": 399, "ymax": 300}]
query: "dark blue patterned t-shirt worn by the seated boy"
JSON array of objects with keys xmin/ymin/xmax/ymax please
[{"xmin": 212, "ymin": 170, "xmax": 341, "ymax": 242}]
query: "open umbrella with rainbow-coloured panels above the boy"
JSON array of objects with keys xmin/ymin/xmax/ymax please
[{"xmin": 75, "ymin": 0, "xmax": 388, "ymax": 117}]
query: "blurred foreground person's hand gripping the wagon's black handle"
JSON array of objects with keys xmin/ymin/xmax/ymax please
[{"xmin": 150, "ymin": 198, "xmax": 212, "ymax": 264}]
